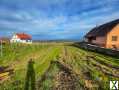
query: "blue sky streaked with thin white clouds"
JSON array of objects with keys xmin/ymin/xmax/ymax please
[{"xmin": 0, "ymin": 0, "xmax": 119, "ymax": 40}]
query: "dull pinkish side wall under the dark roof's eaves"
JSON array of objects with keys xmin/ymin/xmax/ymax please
[{"xmin": 92, "ymin": 36, "xmax": 106, "ymax": 47}]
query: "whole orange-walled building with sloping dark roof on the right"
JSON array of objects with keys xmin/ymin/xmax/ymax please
[{"xmin": 85, "ymin": 19, "xmax": 119, "ymax": 48}]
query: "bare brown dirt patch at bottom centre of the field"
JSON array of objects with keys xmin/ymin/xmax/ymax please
[{"xmin": 54, "ymin": 62, "xmax": 81, "ymax": 90}]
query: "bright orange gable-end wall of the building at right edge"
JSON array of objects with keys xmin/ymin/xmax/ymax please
[{"xmin": 106, "ymin": 24, "xmax": 119, "ymax": 48}]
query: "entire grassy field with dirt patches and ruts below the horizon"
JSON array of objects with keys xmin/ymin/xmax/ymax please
[{"xmin": 0, "ymin": 43, "xmax": 119, "ymax": 90}]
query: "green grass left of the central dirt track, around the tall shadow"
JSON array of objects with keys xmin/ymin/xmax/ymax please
[{"xmin": 0, "ymin": 45, "xmax": 60, "ymax": 90}]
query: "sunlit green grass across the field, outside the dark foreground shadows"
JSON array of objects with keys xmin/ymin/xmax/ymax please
[{"xmin": 0, "ymin": 43, "xmax": 119, "ymax": 90}]
